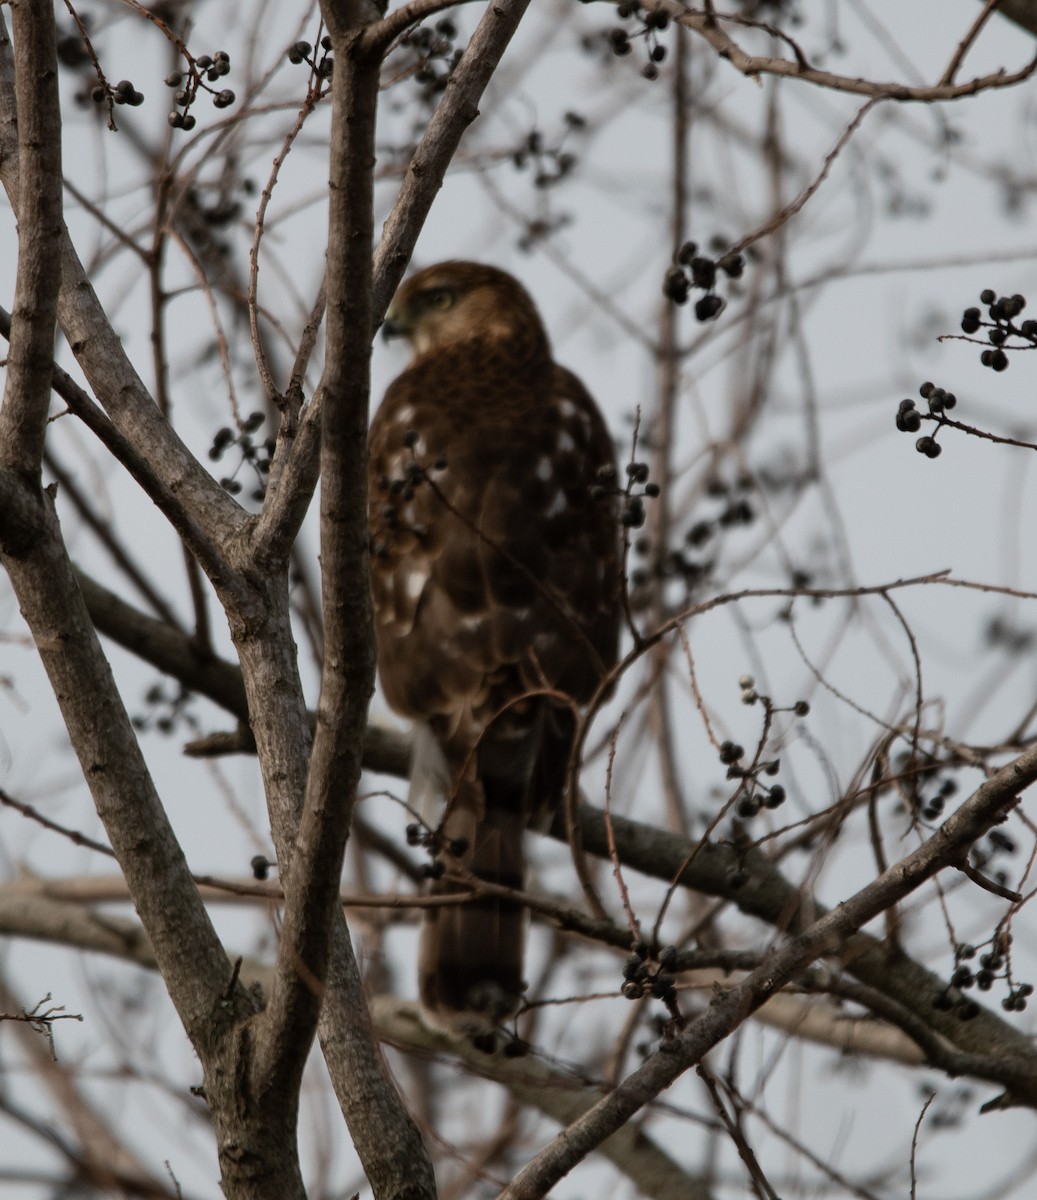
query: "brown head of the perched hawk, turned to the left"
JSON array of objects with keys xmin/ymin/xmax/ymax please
[{"xmin": 382, "ymin": 262, "xmax": 547, "ymax": 359}]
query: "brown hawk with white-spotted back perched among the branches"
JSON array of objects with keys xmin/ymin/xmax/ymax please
[{"xmin": 370, "ymin": 262, "xmax": 619, "ymax": 1036}]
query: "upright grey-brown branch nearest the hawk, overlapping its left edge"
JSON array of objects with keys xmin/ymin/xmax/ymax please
[{"xmin": 257, "ymin": 21, "xmax": 379, "ymax": 1113}]
